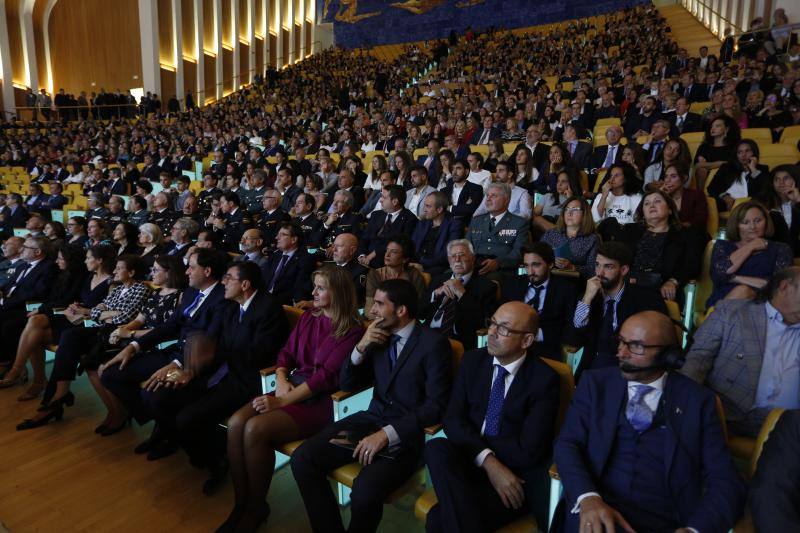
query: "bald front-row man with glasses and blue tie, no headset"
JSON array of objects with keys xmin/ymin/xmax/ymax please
[{"xmin": 425, "ymin": 302, "xmax": 559, "ymax": 533}]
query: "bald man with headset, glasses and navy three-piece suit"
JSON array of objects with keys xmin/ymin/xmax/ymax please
[{"xmin": 555, "ymin": 311, "xmax": 745, "ymax": 533}]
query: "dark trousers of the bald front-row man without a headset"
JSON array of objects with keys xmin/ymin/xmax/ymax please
[{"xmin": 425, "ymin": 439, "xmax": 531, "ymax": 533}]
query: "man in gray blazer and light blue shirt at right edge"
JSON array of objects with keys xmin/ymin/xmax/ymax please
[{"xmin": 681, "ymin": 267, "xmax": 800, "ymax": 437}]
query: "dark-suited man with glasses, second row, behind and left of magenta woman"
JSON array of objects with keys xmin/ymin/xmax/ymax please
[{"xmin": 261, "ymin": 222, "xmax": 316, "ymax": 305}]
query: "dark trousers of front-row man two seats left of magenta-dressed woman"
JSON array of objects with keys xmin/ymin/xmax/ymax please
[{"xmin": 101, "ymin": 351, "xmax": 175, "ymax": 424}]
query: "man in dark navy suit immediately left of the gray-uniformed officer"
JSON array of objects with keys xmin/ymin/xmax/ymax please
[{"xmin": 411, "ymin": 191, "xmax": 464, "ymax": 275}]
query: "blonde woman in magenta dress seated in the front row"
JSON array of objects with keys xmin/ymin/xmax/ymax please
[{"xmin": 218, "ymin": 266, "xmax": 363, "ymax": 531}]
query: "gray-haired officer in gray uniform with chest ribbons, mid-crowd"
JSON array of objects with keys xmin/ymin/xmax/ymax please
[{"xmin": 467, "ymin": 183, "xmax": 530, "ymax": 276}]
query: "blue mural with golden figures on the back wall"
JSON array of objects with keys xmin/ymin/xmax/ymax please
[{"xmin": 317, "ymin": 0, "xmax": 647, "ymax": 48}]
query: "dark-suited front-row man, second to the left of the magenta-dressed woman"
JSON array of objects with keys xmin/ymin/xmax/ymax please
[{"xmin": 98, "ymin": 248, "xmax": 227, "ymax": 460}]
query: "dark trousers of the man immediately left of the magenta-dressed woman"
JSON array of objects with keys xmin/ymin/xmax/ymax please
[{"xmin": 142, "ymin": 374, "xmax": 252, "ymax": 466}]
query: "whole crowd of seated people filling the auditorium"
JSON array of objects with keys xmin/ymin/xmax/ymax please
[{"xmin": 0, "ymin": 6, "xmax": 800, "ymax": 531}]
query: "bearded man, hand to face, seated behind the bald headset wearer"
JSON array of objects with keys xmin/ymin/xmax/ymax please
[{"xmin": 573, "ymin": 242, "xmax": 667, "ymax": 376}]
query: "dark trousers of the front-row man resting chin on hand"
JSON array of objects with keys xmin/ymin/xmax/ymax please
[{"xmin": 292, "ymin": 415, "xmax": 421, "ymax": 533}]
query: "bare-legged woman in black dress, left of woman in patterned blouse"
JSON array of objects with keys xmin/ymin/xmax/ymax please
[{"xmin": 0, "ymin": 244, "xmax": 116, "ymax": 401}]
